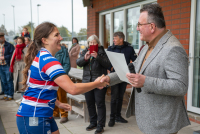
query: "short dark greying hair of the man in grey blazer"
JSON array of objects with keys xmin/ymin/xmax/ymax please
[{"xmin": 140, "ymin": 4, "xmax": 166, "ymax": 28}]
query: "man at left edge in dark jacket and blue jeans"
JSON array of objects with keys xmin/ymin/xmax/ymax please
[{"xmin": 0, "ymin": 33, "xmax": 14, "ymax": 101}]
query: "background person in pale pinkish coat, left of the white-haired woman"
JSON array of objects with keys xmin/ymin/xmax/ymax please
[{"xmin": 69, "ymin": 37, "xmax": 81, "ymax": 68}]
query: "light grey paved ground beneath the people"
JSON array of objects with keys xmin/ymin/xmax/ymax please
[{"xmin": 0, "ymin": 93, "xmax": 200, "ymax": 134}]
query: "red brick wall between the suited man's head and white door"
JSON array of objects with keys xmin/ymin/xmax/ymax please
[{"xmin": 157, "ymin": 0, "xmax": 191, "ymax": 54}]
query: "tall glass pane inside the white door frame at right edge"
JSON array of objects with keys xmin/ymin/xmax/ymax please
[{"xmin": 192, "ymin": 0, "xmax": 200, "ymax": 108}]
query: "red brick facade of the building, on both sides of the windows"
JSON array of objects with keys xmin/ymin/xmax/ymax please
[{"xmin": 87, "ymin": 0, "xmax": 191, "ymax": 54}]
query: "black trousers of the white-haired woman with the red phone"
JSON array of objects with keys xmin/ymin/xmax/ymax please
[{"xmin": 85, "ymin": 88, "xmax": 107, "ymax": 127}]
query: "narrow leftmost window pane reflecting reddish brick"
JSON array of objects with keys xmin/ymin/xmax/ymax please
[{"xmin": 104, "ymin": 14, "xmax": 111, "ymax": 48}]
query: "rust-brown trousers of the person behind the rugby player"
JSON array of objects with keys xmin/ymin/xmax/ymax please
[{"xmin": 53, "ymin": 87, "xmax": 68, "ymax": 117}]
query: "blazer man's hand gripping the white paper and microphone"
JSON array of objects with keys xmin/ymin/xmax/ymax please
[{"xmin": 126, "ymin": 73, "xmax": 146, "ymax": 88}]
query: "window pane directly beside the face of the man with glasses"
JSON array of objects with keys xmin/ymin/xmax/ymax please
[{"xmin": 127, "ymin": 7, "xmax": 140, "ymax": 49}]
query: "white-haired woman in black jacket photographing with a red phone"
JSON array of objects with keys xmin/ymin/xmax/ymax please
[{"xmin": 76, "ymin": 35, "xmax": 111, "ymax": 134}]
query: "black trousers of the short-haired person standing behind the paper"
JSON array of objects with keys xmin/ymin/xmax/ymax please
[{"xmin": 110, "ymin": 82, "xmax": 127, "ymax": 120}]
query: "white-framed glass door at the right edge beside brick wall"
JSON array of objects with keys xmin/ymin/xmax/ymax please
[{"xmin": 188, "ymin": 0, "xmax": 200, "ymax": 114}]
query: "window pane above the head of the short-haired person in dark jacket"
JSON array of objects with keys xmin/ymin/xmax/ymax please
[{"xmin": 114, "ymin": 11, "xmax": 124, "ymax": 33}]
